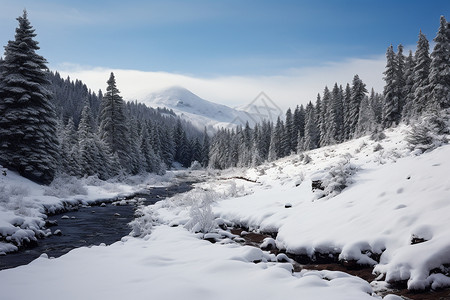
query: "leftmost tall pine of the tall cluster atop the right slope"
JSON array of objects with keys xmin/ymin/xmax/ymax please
[{"xmin": 383, "ymin": 45, "xmax": 403, "ymax": 128}]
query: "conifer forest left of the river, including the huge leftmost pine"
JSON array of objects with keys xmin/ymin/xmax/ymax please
[{"xmin": 0, "ymin": 11, "xmax": 209, "ymax": 184}]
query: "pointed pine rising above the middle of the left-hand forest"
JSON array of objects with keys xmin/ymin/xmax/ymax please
[{"xmin": 99, "ymin": 72, "xmax": 130, "ymax": 171}]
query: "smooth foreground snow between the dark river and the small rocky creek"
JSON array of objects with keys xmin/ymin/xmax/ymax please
[{"xmin": 0, "ymin": 226, "xmax": 374, "ymax": 300}]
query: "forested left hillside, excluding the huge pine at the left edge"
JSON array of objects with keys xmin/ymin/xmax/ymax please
[{"xmin": 51, "ymin": 73, "xmax": 207, "ymax": 179}]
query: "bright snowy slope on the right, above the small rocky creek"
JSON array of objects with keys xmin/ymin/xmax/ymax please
[{"xmin": 211, "ymin": 127, "xmax": 450, "ymax": 289}]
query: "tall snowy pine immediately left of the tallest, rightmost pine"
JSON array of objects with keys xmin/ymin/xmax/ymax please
[{"xmin": 412, "ymin": 31, "xmax": 431, "ymax": 117}]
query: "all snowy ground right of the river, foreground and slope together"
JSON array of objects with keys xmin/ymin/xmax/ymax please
[{"xmin": 0, "ymin": 126, "xmax": 450, "ymax": 299}]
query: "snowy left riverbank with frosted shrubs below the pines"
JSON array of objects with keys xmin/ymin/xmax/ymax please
[{"xmin": 0, "ymin": 171, "xmax": 173, "ymax": 254}]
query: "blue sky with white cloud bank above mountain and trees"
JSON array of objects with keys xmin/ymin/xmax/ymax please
[{"xmin": 0, "ymin": 0, "xmax": 450, "ymax": 108}]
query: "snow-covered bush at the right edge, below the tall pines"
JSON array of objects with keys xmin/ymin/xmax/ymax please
[{"xmin": 406, "ymin": 112, "xmax": 449, "ymax": 153}]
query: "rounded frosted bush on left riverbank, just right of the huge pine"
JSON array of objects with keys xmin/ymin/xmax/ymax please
[{"xmin": 44, "ymin": 174, "xmax": 87, "ymax": 198}]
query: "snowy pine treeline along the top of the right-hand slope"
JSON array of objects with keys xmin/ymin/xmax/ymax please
[{"xmin": 209, "ymin": 16, "xmax": 450, "ymax": 169}]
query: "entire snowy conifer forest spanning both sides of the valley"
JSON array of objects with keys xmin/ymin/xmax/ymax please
[{"xmin": 0, "ymin": 11, "xmax": 450, "ymax": 184}]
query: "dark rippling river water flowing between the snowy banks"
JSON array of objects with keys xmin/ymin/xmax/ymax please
[{"xmin": 0, "ymin": 182, "xmax": 192, "ymax": 270}]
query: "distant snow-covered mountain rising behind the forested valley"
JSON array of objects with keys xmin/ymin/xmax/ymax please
[{"xmin": 143, "ymin": 87, "xmax": 272, "ymax": 131}]
